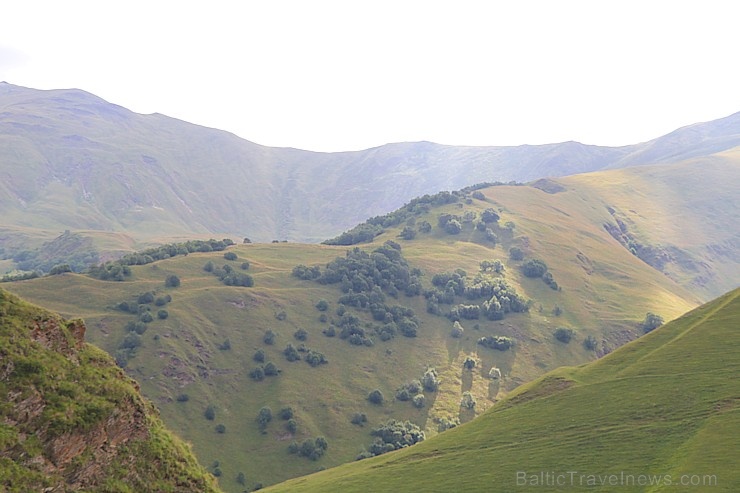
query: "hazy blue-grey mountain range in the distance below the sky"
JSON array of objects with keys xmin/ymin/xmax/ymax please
[{"xmin": 0, "ymin": 83, "xmax": 740, "ymax": 252}]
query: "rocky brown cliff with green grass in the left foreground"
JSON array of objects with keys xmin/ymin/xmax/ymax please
[{"xmin": 0, "ymin": 290, "xmax": 217, "ymax": 492}]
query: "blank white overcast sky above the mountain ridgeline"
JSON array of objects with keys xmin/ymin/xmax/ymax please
[{"xmin": 0, "ymin": 0, "xmax": 740, "ymax": 151}]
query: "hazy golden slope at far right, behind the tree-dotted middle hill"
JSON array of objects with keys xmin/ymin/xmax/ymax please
[{"xmin": 558, "ymin": 148, "xmax": 740, "ymax": 300}]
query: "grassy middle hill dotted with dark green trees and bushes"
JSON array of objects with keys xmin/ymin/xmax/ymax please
[{"xmin": 5, "ymin": 173, "xmax": 702, "ymax": 492}]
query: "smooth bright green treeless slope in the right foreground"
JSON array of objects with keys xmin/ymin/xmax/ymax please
[{"xmin": 267, "ymin": 290, "xmax": 740, "ymax": 492}]
